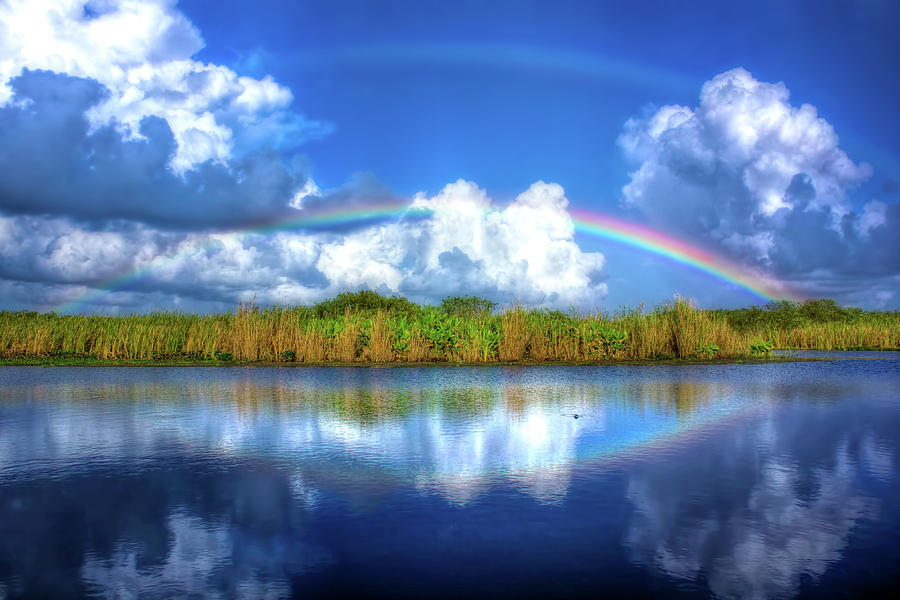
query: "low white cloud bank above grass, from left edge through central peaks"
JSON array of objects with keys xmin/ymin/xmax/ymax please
[{"xmin": 0, "ymin": 178, "xmax": 606, "ymax": 312}]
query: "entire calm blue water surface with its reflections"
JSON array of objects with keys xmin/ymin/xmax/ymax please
[{"xmin": 0, "ymin": 353, "xmax": 900, "ymax": 599}]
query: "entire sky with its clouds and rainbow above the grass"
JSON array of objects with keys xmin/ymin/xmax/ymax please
[{"xmin": 0, "ymin": 0, "xmax": 900, "ymax": 314}]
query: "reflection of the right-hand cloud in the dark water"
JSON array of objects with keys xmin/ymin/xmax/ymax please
[{"xmin": 624, "ymin": 418, "xmax": 885, "ymax": 598}]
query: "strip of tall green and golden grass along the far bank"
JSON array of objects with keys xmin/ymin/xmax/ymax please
[{"xmin": 0, "ymin": 300, "xmax": 900, "ymax": 364}]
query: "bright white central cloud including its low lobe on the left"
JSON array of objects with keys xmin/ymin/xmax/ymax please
[{"xmin": 317, "ymin": 180, "xmax": 606, "ymax": 307}]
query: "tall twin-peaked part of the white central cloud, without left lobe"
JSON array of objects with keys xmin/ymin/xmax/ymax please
[{"xmin": 403, "ymin": 180, "xmax": 606, "ymax": 306}]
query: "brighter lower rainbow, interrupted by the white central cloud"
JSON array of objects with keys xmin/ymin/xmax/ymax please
[{"xmin": 56, "ymin": 201, "xmax": 800, "ymax": 314}]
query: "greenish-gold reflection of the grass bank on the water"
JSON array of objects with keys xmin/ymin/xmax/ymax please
[{"xmin": 0, "ymin": 370, "xmax": 732, "ymax": 423}]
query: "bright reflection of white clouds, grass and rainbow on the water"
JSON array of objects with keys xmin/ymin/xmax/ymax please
[{"xmin": 0, "ymin": 370, "xmax": 752, "ymax": 504}]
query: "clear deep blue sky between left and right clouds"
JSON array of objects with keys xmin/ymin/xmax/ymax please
[{"xmin": 185, "ymin": 1, "xmax": 900, "ymax": 190}]
